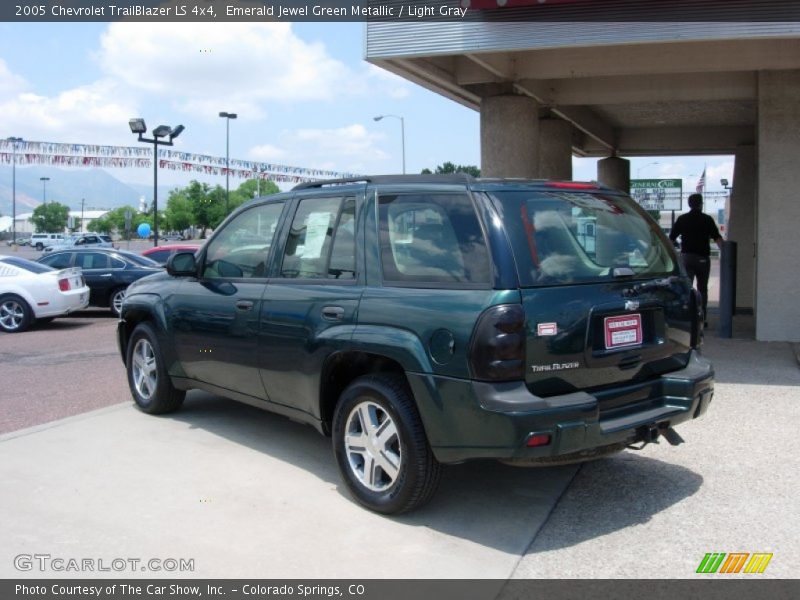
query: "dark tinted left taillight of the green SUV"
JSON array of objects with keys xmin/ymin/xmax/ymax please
[{"xmin": 470, "ymin": 304, "xmax": 525, "ymax": 381}]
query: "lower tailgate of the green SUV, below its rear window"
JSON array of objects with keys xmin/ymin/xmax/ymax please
[{"xmin": 522, "ymin": 278, "xmax": 692, "ymax": 396}]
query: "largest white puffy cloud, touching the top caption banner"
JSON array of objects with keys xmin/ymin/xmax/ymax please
[{"xmin": 96, "ymin": 23, "xmax": 356, "ymax": 118}]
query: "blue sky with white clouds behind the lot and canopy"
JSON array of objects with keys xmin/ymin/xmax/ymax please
[{"xmin": 0, "ymin": 23, "xmax": 733, "ymax": 195}]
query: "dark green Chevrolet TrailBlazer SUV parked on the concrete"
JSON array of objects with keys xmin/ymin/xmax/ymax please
[{"xmin": 118, "ymin": 175, "xmax": 714, "ymax": 513}]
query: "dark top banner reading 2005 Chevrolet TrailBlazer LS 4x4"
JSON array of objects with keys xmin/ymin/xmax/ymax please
[{"xmin": 0, "ymin": 0, "xmax": 800, "ymax": 23}]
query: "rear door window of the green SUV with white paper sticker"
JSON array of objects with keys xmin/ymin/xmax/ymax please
[{"xmin": 281, "ymin": 196, "xmax": 356, "ymax": 280}]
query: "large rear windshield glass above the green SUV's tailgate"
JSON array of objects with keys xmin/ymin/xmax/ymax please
[{"xmin": 493, "ymin": 190, "xmax": 677, "ymax": 287}]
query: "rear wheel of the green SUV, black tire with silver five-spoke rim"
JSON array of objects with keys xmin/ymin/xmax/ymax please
[{"xmin": 333, "ymin": 374, "xmax": 441, "ymax": 514}]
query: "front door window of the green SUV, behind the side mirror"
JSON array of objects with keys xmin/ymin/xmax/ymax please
[{"xmin": 203, "ymin": 203, "xmax": 283, "ymax": 279}]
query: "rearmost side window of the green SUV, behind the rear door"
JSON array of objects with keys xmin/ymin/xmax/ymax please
[{"xmin": 378, "ymin": 193, "xmax": 490, "ymax": 284}]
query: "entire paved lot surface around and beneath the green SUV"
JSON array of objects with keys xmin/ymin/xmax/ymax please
[{"xmin": 0, "ymin": 246, "xmax": 800, "ymax": 579}]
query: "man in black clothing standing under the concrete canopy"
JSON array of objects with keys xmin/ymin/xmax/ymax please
[{"xmin": 669, "ymin": 194, "xmax": 722, "ymax": 327}]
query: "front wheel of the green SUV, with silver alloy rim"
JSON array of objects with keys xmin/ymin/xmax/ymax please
[{"xmin": 125, "ymin": 323, "xmax": 186, "ymax": 415}]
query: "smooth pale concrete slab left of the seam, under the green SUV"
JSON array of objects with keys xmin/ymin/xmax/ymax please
[{"xmin": 0, "ymin": 392, "xmax": 576, "ymax": 579}]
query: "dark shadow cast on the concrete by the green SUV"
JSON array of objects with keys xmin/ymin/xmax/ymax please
[{"xmin": 165, "ymin": 391, "xmax": 701, "ymax": 555}]
